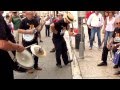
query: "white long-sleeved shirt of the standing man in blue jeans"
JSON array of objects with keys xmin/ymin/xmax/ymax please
[{"xmin": 87, "ymin": 13, "xmax": 104, "ymax": 27}]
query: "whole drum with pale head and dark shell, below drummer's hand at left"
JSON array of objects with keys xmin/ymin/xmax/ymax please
[{"xmin": 13, "ymin": 50, "xmax": 34, "ymax": 72}]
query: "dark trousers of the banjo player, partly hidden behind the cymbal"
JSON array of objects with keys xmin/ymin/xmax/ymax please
[{"xmin": 23, "ymin": 40, "xmax": 38, "ymax": 68}]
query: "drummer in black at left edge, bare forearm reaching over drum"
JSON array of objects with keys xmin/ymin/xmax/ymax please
[{"xmin": 0, "ymin": 11, "xmax": 25, "ymax": 80}]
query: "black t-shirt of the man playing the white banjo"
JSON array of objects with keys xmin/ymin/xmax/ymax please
[{"xmin": 19, "ymin": 18, "xmax": 39, "ymax": 46}]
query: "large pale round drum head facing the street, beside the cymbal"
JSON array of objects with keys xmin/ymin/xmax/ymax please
[{"xmin": 16, "ymin": 50, "xmax": 34, "ymax": 68}]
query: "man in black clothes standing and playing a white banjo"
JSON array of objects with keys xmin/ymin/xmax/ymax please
[{"xmin": 18, "ymin": 11, "xmax": 43, "ymax": 73}]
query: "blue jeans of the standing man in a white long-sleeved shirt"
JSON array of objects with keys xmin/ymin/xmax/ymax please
[{"xmin": 90, "ymin": 27, "xmax": 101, "ymax": 48}]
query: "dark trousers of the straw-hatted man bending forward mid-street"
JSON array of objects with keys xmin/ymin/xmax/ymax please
[{"xmin": 53, "ymin": 38, "xmax": 68, "ymax": 65}]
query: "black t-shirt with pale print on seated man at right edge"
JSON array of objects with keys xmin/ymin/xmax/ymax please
[{"xmin": 112, "ymin": 28, "xmax": 120, "ymax": 44}]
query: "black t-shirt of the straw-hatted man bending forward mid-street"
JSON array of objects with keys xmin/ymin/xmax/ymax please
[{"xmin": 53, "ymin": 19, "xmax": 68, "ymax": 39}]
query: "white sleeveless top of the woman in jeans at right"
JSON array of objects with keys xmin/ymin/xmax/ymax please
[{"xmin": 105, "ymin": 17, "xmax": 115, "ymax": 32}]
